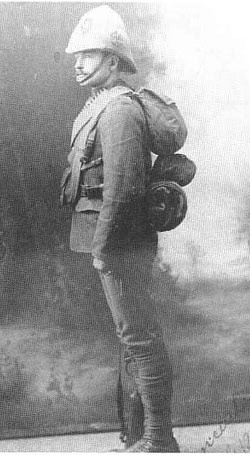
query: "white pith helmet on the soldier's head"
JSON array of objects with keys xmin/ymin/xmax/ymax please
[{"xmin": 65, "ymin": 5, "xmax": 137, "ymax": 74}]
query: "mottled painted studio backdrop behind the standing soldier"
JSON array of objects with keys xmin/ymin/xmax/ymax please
[{"xmin": 0, "ymin": 0, "xmax": 250, "ymax": 438}]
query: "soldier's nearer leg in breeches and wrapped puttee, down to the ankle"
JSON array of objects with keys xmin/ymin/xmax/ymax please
[{"xmin": 97, "ymin": 248, "xmax": 172, "ymax": 448}]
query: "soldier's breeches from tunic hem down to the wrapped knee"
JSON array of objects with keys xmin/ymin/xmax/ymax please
[{"xmin": 97, "ymin": 243, "xmax": 161, "ymax": 352}]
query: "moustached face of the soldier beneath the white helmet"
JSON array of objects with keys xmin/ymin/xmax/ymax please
[{"xmin": 75, "ymin": 51, "xmax": 110, "ymax": 87}]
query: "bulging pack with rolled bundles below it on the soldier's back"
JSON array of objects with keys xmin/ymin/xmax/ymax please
[{"xmin": 129, "ymin": 88, "xmax": 196, "ymax": 232}]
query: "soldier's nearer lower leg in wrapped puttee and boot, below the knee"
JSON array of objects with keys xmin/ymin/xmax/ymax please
[{"xmin": 122, "ymin": 339, "xmax": 179, "ymax": 453}]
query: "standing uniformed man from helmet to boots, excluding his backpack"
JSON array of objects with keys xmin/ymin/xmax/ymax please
[{"xmin": 62, "ymin": 5, "xmax": 187, "ymax": 452}]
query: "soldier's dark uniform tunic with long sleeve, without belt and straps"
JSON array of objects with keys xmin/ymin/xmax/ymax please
[{"xmin": 70, "ymin": 83, "xmax": 156, "ymax": 261}]
